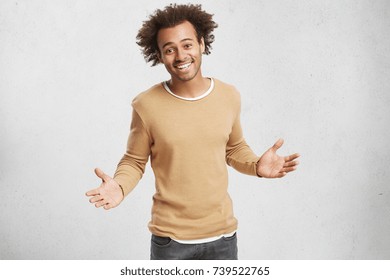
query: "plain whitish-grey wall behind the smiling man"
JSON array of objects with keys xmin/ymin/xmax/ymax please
[{"xmin": 0, "ymin": 0, "xmax": 390, "ymax": 259}]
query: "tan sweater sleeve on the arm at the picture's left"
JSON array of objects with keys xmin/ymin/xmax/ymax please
[{"xmin": 114, "ymin": 109, "xmax": 151, "ymax": 196}]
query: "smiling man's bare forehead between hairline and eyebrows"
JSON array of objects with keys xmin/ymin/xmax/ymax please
[{"xmin": 157, "ymin": 21, "xmax": 197, "ymax": 47}]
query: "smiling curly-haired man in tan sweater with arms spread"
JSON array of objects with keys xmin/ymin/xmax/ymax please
[{"xmin": 87, "ymin": 5, "xmax": 299, "ymax": 259}]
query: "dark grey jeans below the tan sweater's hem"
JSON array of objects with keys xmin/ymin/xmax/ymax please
[{"xmin": 150, "ymin": 234, "xmax": 237, "ymax": 260}]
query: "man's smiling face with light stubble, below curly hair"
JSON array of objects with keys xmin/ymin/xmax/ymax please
[{"xmin": 157, "ymin": 21, "xmax": 204, "ymax": 81}]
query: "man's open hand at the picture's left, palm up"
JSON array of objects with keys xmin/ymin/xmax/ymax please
[{"xmin": 86, "ymin": 168, "xmax": 124, "ymax": 210}]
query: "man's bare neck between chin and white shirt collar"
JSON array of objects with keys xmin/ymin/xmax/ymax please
[{"xmin": 168, "ymin": 76, "xmax": 210, "ymax": 98}]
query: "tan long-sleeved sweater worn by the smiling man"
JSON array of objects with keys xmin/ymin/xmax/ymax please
[{"xmin": 114, "ymin": 79, "xmax": 258, "ymax": 240}]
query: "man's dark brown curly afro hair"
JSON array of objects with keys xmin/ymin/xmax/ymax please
[{"xmin": 137, "ymin": 4, "xmax": 218, "ymax": 66}]
